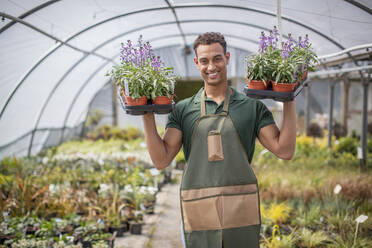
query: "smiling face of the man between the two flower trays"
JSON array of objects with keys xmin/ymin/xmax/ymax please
[{"xmin": 194, "ymin": 43, "xmax": 230, "ymax": 86}]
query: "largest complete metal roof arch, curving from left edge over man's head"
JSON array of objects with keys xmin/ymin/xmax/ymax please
[{"xmin": 0, "ymin": 4, "xmax": 352, "ymax": 119}]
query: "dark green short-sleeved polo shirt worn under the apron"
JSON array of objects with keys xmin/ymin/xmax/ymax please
[{"xmin": 166, "ymin": 87, "xmax": 275, "ymax": 163}]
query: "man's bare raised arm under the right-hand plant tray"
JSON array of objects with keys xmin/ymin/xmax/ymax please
[{"xmin": 258, "ymin": 100, "xmax": 296, "ymax": 160}]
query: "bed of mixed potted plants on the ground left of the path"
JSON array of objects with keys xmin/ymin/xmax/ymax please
[{"xmin": 0, "ymin": 130, "xmax": 170, "ymax": 245}]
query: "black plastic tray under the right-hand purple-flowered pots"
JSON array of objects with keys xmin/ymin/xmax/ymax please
[{"xmin": 244, "ymin": 83, "xmax": 307, "ymax": 102}]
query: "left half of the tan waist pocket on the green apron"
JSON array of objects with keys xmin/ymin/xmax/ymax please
[{"xmin": 182, "ymin": 197, "xmax": 222, "ymax": 231}]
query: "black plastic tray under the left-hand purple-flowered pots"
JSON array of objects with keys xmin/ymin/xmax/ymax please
[{"xmin": 118, "ymin": 92, "xmax": 175, "ymax": 115}]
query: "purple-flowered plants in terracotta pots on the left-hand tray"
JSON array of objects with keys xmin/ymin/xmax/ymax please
[{"xmin": 106, "ymin": 36, "xmax": 177, "ymax": 106}]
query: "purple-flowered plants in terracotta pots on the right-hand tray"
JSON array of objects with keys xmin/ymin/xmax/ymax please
[{"xmin": 246, "ymin": 26, "xmax": 317, "ymax": 92}]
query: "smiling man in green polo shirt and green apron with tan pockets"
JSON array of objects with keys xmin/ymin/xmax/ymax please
[{"xmin": 143, "ymin": 32, "xmax": 296, "ymax": 248}]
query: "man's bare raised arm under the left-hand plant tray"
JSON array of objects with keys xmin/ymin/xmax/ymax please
[{"xmin": 142, "ymin": 113, "xmax": 182, "ymax": 170}]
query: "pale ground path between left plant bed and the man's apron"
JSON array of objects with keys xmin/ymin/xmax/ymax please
[{"xmin": 115, "ymin": 170, "xmax": 182, "ymax": 248}]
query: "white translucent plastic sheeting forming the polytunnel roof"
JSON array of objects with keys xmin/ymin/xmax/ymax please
[{"xmin": 0, "ymin": 0, "xmax": 372, "ymax": 157}]
